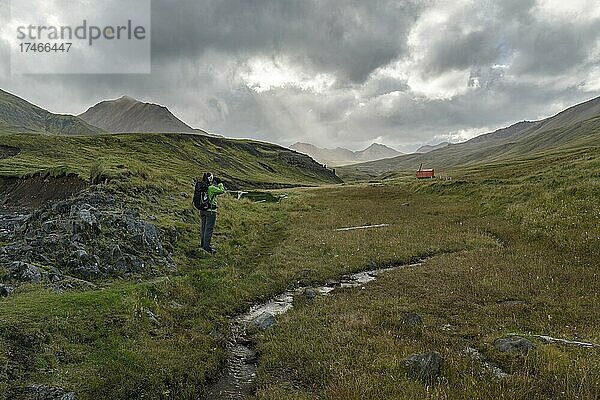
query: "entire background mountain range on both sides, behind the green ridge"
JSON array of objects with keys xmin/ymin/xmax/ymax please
[{"xmin": 0, "ymin": 90, "xmax": 600, "ymax": 177}]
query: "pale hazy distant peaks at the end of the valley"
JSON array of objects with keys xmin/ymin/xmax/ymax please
[{"xmin": 290, "ymin": 142, "xmax": 402, "ymax": 167}]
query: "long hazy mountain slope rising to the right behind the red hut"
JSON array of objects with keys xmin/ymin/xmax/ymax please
[{"xmin": 338, "ymin": 98, "xmax": 600, "ymax": 179}]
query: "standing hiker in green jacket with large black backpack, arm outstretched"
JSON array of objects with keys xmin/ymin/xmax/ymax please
[{"xmin": 194, "ymin": 172, "xmax": 225, "ymax": 254}]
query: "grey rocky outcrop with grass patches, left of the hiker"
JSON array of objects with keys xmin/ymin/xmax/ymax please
[{"xmin": 0, "ymin": 189, "xmax": 173, "ymax": 287}]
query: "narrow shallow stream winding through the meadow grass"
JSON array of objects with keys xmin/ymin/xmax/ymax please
[{"xmin": 206, "ymin": 262, "xmax": 422, "ymax": 400}]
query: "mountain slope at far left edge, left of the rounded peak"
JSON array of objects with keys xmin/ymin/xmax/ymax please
[{"xmin": 0, "ymin": 89, "xmax": 104, "ymax": 135}]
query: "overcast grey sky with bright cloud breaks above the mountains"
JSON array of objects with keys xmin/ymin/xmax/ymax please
[{"xmin": 0, "ymin": 0, "xmax": 600, "ymax": 151}]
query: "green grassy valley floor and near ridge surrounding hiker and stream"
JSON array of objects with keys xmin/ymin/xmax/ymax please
[{"xmin": 0, "ymin": 135, "xmax": 600, "ymax": 399}]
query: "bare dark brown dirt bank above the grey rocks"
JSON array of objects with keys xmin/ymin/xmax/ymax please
[{"xmin": 0, "ymin": 175, "xmax": 88, "ymax": 209}]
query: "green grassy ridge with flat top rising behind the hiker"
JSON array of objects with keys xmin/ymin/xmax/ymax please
[{"xmin": 0, "ymin": 134, "xmax": 340, "ymax": 191}]
